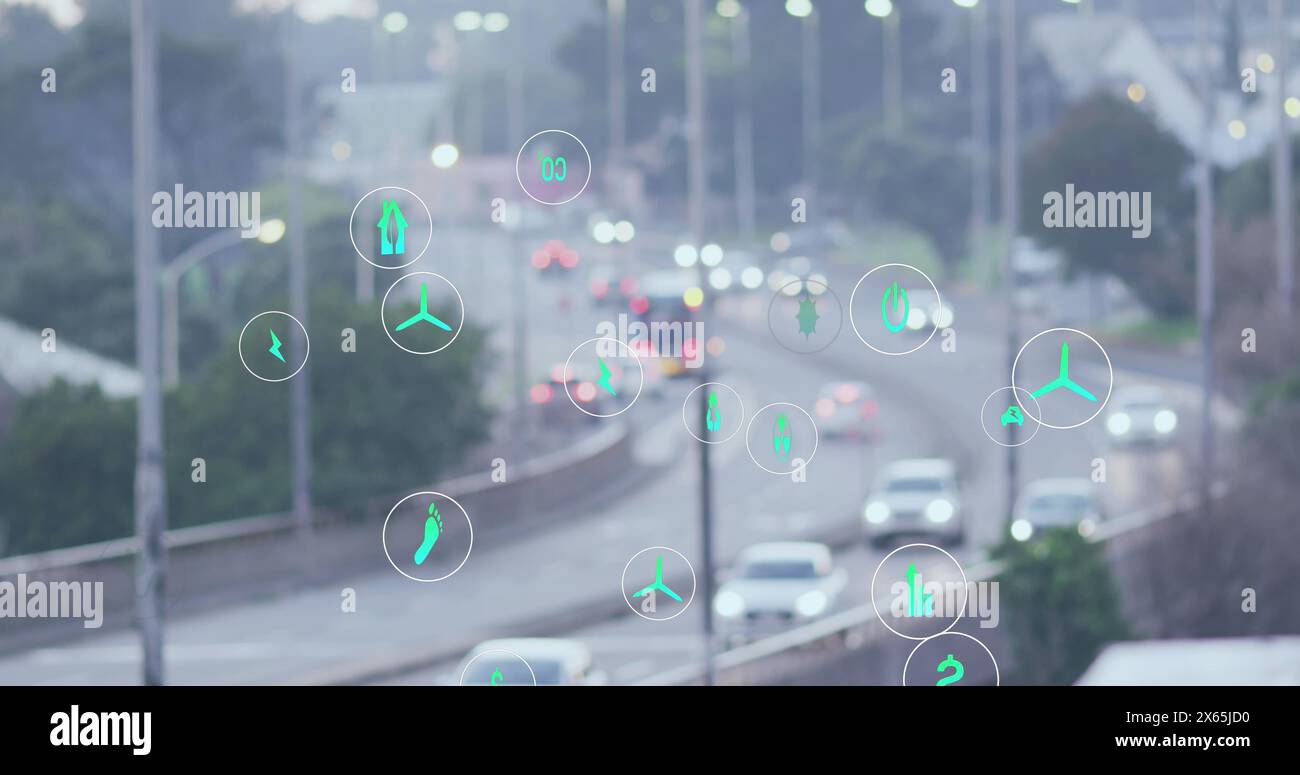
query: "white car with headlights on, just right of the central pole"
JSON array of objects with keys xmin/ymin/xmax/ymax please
[{"xmin": 714, "ymin": 541, "xmax": 846, "ymax": 636}]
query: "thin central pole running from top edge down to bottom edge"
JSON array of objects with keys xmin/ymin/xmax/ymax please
[{"xmin": 685, "ymin": 0, "xmax": 716, "ymax": 687}]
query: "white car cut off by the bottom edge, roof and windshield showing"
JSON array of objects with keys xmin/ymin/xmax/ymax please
[{"xmin": 454, "ymin": 637, "xmax": 606, "ymax": 687}]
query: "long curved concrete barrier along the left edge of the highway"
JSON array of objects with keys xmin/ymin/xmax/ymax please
[{"xmin": 0, "ymin": 423, "xmax": 637, "ymax": 653}]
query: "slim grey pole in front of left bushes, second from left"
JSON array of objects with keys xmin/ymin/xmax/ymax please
[{"xmin": 283, "ymin": 5, "xmax": 312, "ymax": 536}]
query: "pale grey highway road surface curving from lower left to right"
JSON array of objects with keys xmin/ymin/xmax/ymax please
[{"xmin": 0, "ymin": 228, "xmax": 1196, "ymax": 684}]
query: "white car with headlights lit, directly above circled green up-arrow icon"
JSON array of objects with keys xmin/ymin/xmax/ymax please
[{"xmin": 862, "ymin": 458, "xmax": 963, "ymax": 544}]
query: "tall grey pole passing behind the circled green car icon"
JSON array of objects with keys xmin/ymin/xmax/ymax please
[{"xmin": 1001, "ymin": 0, "xmax": 1021, "ymax": 527}]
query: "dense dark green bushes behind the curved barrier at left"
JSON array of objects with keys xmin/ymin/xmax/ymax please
[{"xmin": 0, "ymin": 287, "xmax": 490, "ymax": 554}]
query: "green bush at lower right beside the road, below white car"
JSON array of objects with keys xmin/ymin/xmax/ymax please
[{"xmin": 992, "ymin": 528, "xmax": 1128, "ymax": 685}]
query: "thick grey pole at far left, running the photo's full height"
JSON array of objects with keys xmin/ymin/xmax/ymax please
[{"xmin": 131, "ymin": 0, "xmax": 166, "ymax": 687}]
